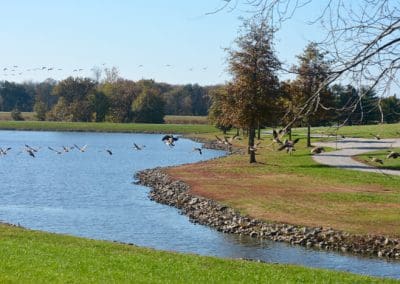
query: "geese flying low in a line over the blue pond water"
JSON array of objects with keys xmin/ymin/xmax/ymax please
[{"xmin": 0, "ymin": 135, "xmax": 203, "ymax": 158}]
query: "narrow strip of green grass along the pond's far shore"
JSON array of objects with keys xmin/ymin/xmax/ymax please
[{"xmin": 0, "ymin": 121, "xmax": 217, "ymax": 134}]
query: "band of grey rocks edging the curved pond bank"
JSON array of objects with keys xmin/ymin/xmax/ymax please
[{"xmin": 136, "ymin": 168, "xmax": 400, "ymax": 259}]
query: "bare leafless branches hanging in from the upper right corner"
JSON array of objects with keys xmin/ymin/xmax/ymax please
[{"xmin": 214, "ymin": 0, "xmax": 400, "ymax": 126}]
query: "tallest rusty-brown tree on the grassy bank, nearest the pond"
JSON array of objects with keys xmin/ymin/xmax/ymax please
[{"xmin": 224, "ymin": 18, "xmax": 280, "ymax": 163}]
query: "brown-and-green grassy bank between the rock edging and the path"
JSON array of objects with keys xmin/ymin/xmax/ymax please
[{"xmin": 168, "ymin": 129, "xmax": 400, "ymax": 237}]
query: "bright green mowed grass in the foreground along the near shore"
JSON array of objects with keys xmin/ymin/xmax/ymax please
[{"xmin": 0, "ymin": 224, "xmax": 399, "ymax": 283}]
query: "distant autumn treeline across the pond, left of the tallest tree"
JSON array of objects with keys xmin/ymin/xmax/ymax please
[{"xmin": 0, "ymin": 77, "xmax": 215, "ymax": 123}]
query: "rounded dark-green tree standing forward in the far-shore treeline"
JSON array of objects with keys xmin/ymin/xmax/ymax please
[{"xmin": 132, "ymin": 86, "xmax": 165, "ymax": 123}]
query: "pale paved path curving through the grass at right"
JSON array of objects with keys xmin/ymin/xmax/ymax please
[{"xmin": 313, "ymin": 138, "xmax": 400, "ymax": 176}]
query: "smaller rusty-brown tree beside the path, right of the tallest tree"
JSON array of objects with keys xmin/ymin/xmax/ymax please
[{"xmin": 292, "ymin": 42, "xmax": 333, "ymax": 147}]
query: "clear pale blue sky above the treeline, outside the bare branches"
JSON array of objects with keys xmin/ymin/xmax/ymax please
[{"xmin": 0, "ymin": 0, "xmax": 319, "ymax": 85}]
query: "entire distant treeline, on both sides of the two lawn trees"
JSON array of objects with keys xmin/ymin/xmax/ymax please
[{"xmin": 0, "ymin": 77, "xmax": 400, "ymax": 125}]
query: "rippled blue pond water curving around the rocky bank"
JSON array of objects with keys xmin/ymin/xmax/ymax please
[{"xmin": 0, "ymin": 131, "xmax": 400, "ymax": 278}]
